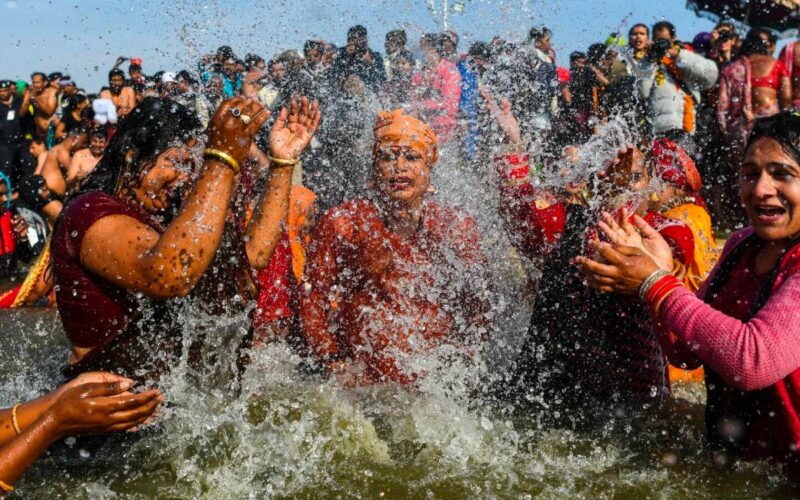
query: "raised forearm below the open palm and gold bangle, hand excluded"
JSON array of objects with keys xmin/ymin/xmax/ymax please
[{"xmin": 247, "ymin": 165, "xmax": 292, "ymax": 269}]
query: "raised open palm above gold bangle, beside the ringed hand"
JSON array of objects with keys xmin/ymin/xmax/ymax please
[{"xmin": 269, "ymin": 96, "xmax": 321, "ymax": 160}]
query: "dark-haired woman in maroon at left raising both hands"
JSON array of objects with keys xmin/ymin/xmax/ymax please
[{"xmin": 51, "ymin": 98, "xmax": 320, "ymax": 378}]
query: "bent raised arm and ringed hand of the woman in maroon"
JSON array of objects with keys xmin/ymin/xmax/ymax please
[{"xmin": 81, "ymin": 98, "xmax": 269, "ymax": 298}]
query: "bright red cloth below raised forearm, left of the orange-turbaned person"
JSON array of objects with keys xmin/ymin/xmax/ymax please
[{"xmin": 253, "ymin": 233, "xmax": 296, "ymax": 328}]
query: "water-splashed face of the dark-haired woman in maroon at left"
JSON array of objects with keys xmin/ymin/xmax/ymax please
[{"xmin": 131, "ymin": 146, "xmax": 194, "ymax": 215}]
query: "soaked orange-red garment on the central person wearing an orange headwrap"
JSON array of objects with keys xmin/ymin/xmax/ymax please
[{"xmin": 299, "ymin": 199, "xmax": 489, "ymax": 383}]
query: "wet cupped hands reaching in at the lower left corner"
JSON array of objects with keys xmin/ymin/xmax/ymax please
[{"xmin": 46, "ymin": 373, "xmax": 164, "ymax": 436}]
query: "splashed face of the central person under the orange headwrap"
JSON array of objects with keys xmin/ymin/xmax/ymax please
[{"xmin": 372, "ymin": 142, "xmax": 431, "ymax": 206}]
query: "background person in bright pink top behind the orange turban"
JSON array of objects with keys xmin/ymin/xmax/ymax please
[{"xmin": 411, "ymin": 34, "xmax": 461, "ymax": 145}]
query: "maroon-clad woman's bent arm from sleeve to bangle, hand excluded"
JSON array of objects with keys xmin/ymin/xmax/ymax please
[{"xmin": 81, "ymin": 158, "xmax": 234, "ymax": 298}]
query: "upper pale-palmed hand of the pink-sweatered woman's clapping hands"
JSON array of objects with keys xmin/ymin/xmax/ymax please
[{"xmin": 599, "ymin": 208, "xmax": 674, "ymax": 271}]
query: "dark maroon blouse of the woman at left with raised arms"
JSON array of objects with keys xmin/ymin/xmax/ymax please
[{"xmin": 51, "ymin": 192, "xmax": 162, "ymax": 348}]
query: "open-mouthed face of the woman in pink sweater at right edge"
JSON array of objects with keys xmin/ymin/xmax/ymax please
[{"xmin": 739, "ymin": 138, "xmax": 800, "ymax": 241}]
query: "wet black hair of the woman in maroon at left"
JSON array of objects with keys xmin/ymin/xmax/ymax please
[{"xmin": 71, "ymin": 97, "xmax": 201, "ymax": 198}]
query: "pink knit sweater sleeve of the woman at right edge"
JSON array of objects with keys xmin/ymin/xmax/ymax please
[{"xmin": 655, "ymin": 228, "xmax": 800, "ymax": 391}]
